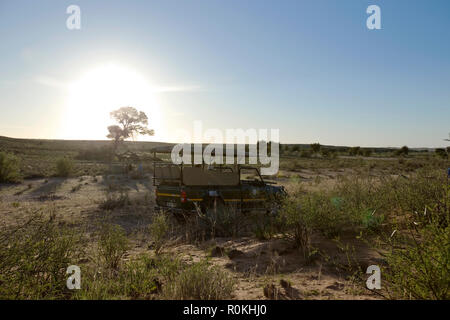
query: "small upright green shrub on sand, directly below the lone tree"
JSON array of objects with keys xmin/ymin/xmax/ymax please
[{"xmin": 98, "ymin": 224, "xmax": 128, "ymax": 270}]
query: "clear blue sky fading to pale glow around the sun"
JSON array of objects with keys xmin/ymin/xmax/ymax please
[{"xmin": 0, "ymin": 0, "xmax": 450, "ymax": 147}]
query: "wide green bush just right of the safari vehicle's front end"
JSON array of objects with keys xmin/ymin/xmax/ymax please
[{"xmin": 281, "ymin": 176, "xmax": 389, "ymax": 239}]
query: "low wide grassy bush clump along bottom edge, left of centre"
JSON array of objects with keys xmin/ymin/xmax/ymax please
[{"xmin": 74, "ymin": 255, "xmax": 235, "ymax": 300}]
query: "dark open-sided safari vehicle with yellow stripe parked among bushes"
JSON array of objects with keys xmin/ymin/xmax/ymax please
[{"xmin": 153, "ymin": 162, "xmax": 286, "ymax": 213}]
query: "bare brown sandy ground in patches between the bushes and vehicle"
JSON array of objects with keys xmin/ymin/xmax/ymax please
[{"xmin": 0, "ymin": 171, "xmax": 379, "ymax": 299}]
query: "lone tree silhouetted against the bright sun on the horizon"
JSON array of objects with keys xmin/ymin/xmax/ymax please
[{"xmin": 106, "ymin": 107, "xmax": 155, "ymax": 152}]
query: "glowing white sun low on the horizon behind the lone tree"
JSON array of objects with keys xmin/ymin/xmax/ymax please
[{"xmin": 63, "ymin": 64, "xmax": 162, "ymax": 140}]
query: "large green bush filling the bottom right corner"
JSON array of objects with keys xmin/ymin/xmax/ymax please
[{"xmin": 382, "ymin": 200, "xmax": 450, "ymax": 300}]
